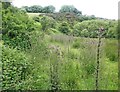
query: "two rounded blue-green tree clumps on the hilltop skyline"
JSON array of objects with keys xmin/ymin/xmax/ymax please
[{"xmin": 21, "ymin": 5, "xmax": 82, "ymax": 15}]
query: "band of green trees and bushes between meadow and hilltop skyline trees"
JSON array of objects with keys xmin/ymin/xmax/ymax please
[{"xmin": 33, "ymin": 14, "xmax": 118, "ymax": 38}]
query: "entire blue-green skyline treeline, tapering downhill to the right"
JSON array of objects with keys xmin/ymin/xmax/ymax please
[{"xmin": 20, "ymin": 5, "xmax": 114, "ymax": 22}]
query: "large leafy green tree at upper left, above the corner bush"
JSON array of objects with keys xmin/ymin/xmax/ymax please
[{"xmin": 2, "ymin": 2, "xmax": 35, "ymax": 49}]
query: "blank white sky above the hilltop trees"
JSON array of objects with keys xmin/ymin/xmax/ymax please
[{"xmin": 13, "ymin": 0, "xmax": 119, "ymax": 19}]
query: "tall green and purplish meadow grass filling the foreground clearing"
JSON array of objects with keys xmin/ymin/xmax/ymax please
[{"xmin": 20, "ymin": 33, "xmax": 118, "ymax": 91}]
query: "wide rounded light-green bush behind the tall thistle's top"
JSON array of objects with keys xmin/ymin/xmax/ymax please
[{"xmin": 73, "ymin": 19, "xmax": 117, "ymax": 38}]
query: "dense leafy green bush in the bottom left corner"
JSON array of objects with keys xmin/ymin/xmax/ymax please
[{"xmin": 2, "ymin": 46, "xmax": 30, "ymax": 90}]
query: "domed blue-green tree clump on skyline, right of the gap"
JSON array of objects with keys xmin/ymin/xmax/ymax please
[{"xmin": 59, "ymin": 5, "xmax": 82, "ymax": 14}]
